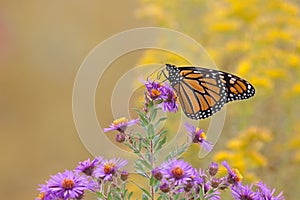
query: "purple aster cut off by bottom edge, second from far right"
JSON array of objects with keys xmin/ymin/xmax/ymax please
[{"xmin": 231, "ymin": 184, "xmax": 257, "ymax": 200}]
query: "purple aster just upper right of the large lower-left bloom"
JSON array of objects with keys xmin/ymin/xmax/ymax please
[{"xmin": 94, "ymin": 158, "xmax": 127, "ymax": 181}]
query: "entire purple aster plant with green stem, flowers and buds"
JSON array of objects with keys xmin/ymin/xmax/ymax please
[{"xmin": 36, "ymin": 80, "xmax": 285, "ymax": 200}]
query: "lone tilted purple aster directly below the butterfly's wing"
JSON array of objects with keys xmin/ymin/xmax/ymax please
[{"xmin": 185, "ymin": 123, "xmax": 213, "ymax": 151}]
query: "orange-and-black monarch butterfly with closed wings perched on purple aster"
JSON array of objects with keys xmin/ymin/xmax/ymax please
[{"xmin": 159, "ymin": 64, "xmax": 255, "ymax": 120}]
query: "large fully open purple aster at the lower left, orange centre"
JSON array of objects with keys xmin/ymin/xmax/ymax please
[{"xmin": 47, "ymin": 170, "xmax": 94, "ymax": 199}]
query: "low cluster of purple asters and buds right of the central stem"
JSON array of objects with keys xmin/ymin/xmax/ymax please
[{"xmin": 152, "ymin": 159, "xmax": 285, "ymax": 200}]
